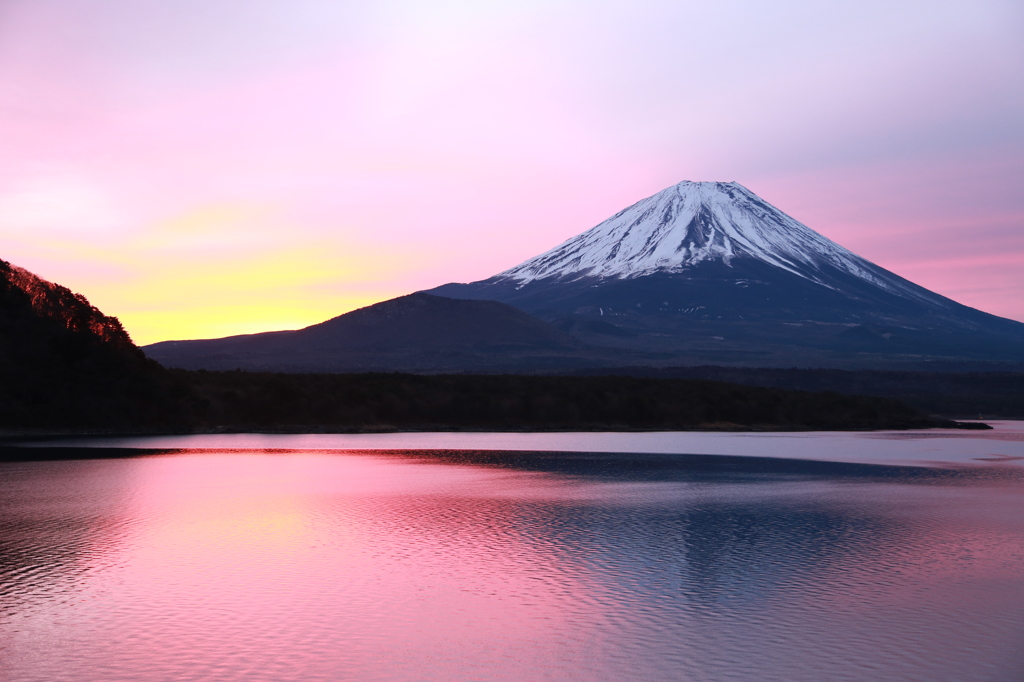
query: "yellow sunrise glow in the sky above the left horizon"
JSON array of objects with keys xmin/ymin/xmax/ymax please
[{"xmin": 23, "ymin": 199, "xmax": 423, "ymax": 345}]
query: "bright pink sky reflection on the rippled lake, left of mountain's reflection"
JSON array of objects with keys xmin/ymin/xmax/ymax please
[{"xmin": 74, "ymin": 454, "xmax": 600, "ymax": 679}]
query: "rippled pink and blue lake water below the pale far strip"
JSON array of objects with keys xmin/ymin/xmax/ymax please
[{"xmin": 0, "ymin": 451, "xmax": 1024, "ymax": 682}]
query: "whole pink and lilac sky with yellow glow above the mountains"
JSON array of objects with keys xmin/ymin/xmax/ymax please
[{"xmin": 0, "ymin": 0, "xmax": 1024, "ymax": 343}]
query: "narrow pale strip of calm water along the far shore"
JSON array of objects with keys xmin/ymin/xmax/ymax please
[{"xmin": 0, "ymin": 420, "xmax": 1024, "ymax": 469}]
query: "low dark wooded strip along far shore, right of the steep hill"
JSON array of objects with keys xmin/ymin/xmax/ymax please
[{"xmin": 172, "ymin": 370, "xmax": 936, "ymax": 431}]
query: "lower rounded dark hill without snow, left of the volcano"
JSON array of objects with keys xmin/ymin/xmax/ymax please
[{"xmin": 143, "ymin": 293, "xmax": 582, "ymax": 372}]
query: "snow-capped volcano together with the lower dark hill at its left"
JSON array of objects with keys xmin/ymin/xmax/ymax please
[{"xmin": 144, "ymin": 182, "xmax": 1024, "ymax": 372}]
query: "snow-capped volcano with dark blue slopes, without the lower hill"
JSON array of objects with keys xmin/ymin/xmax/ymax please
[{"xmin": 428, "ymin": 181, "xmax": 1024, "ymax": 369}]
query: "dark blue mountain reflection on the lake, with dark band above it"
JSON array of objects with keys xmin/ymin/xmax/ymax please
[{"xmin": 385, "ymin": 451, "xmax": 1024, "ymax": 611}]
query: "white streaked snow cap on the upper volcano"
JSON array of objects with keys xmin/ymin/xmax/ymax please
[{"xmin": 495, "ymin": 181, "xmax": 920, "ymax": 297}]
